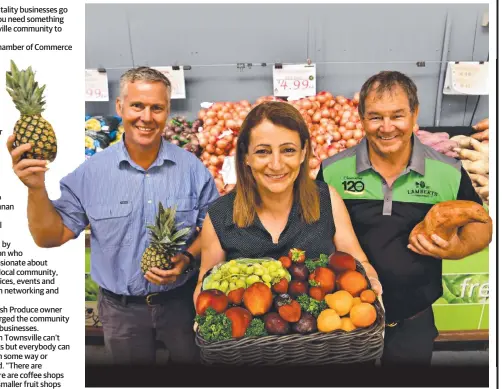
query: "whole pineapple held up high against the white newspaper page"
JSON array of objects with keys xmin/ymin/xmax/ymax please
[{"xmin": 6, "ymin": 60, "xmax": 57, "ymax": 162}]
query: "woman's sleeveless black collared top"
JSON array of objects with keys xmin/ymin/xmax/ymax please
[{"xmin": 208, "ymin": 182, "xmax": 335, "ymax": 260}]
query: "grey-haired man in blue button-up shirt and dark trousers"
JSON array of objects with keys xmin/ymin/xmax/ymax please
[{"xmin": 8, "ymin": 67, "xmax": 218, "ymax": 364}]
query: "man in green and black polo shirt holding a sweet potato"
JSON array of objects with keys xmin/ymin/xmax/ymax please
[{"xmin": 317, "ymin": 72, "xmax": 492, "ymax": 365}]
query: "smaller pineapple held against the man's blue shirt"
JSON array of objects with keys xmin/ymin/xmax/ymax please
[{"xmin": 141, "ymin": 202, "xmax": 190, "ymax": 273}]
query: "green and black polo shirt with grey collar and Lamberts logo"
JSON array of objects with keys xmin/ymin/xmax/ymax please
[{"xmin": 318, "ymin": 135, "xmax": 482, "ymax": 321}]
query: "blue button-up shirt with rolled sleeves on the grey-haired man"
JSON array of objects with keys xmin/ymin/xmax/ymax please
[{"xmin": 52, "ymin": 140, "xmax": 219, "ymax": 296}]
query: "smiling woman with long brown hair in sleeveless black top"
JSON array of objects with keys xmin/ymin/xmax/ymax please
[{"xmin": 194, "ymin": 102, "xmax": 381, "ymax": 301}]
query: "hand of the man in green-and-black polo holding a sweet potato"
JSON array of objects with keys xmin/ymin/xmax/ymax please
[{"xmin": 408, "ymin": 234, "xmax": 465, "ymax": 259}]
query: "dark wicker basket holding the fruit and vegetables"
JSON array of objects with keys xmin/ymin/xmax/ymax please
[{"xmin": 195, "ymin": 262, "xmax": 385, "ymax": 365}]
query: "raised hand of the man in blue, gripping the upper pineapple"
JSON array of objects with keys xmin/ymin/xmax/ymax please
[{"xmin": 7, "ymin": 135, "xmax": 49, "ymax": 189}]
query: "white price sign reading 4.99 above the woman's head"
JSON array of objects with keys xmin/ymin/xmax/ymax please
[{"xmin": 274, "ymin": 64, "xmax": 316, "ymax": 98}]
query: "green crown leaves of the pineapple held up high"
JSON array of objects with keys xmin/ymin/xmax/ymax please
[{"xmin": 5, "ymin": 60, "xmax": 45, "ymax": 115}]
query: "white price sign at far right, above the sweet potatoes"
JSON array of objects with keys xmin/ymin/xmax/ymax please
[{"xmin": 443, "ymin": 62, "xmax": 489, "ymax": 95}]
